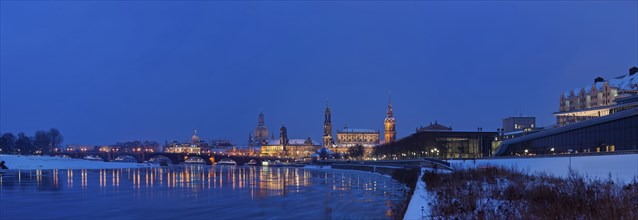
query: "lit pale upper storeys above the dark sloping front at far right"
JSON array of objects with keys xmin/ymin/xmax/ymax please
[{"xmin": 554, "ymin": 67, "xmax": 638, "ymax": 126}]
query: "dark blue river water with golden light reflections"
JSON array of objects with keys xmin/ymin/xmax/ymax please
[{"xmin": 0, "ymin": 165, "xmax": 406, "ymax": 219}]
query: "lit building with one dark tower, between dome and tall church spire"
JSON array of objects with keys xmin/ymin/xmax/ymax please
[{"xmin": 261, "ymin": 125, "xmax": 321, "ymax": 158}]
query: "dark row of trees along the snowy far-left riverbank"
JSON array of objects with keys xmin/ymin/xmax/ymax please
[{"xmin": 0, "ymin": 128, "xmax": 64, "ymax": 155}]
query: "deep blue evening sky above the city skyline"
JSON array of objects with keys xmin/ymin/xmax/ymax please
[{"xmin": 0, "ymin": 1, "xmax": 638, "ymax": 144}]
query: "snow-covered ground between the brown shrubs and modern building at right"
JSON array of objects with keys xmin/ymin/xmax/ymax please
[{"xmin": 450, "ymin": 154, "xmax": 638, "ymax": 183}]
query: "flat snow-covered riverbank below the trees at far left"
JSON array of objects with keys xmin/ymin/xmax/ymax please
[{"xmin": 0, "ymin": 154, "xmax": 157, "ymax": 170}]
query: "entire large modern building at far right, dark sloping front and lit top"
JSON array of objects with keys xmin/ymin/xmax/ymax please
[{"xmin": 496, "ymin": 67, "xmax": 638, "ymax": 155}]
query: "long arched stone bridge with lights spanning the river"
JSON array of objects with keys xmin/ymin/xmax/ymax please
[{"xmin": 53, "ymin": 152, "xmax": 287, "ymax": 165}]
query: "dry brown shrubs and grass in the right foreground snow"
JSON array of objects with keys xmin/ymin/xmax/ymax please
[{"xmin": 423, "ymin": 167, "xmax": 638, "ymax": 219}]
